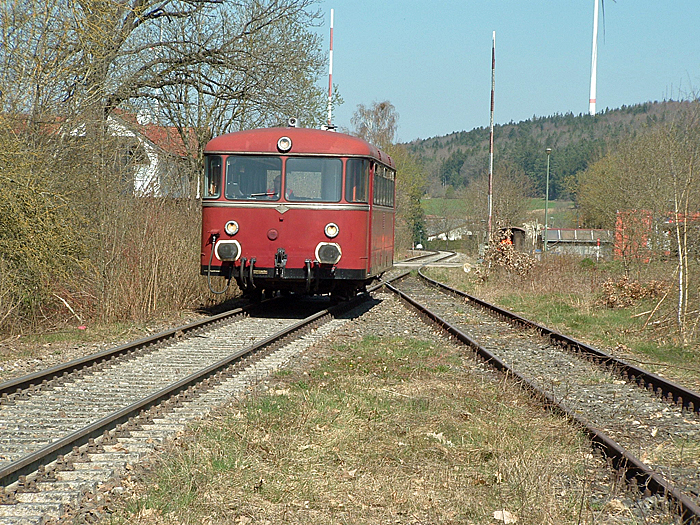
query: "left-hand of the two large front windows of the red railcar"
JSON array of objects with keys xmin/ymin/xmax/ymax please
[{"xmin": 225, "ymin": 155, "xmax": 282, "ymax": 201}]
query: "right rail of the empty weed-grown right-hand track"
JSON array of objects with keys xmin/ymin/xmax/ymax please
[{"xmin": 418, "ymin": 270, "xmax": 700, "ymax": 412}]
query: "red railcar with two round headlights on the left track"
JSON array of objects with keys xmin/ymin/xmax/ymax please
[{"xmin": 201, "ymin": 121, "xmax": 396, "ymax": 296}]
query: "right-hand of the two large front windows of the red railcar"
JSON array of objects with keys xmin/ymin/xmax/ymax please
[{"xmin": 285, "ymin": 157, "xmax": 343, "ymax": 202}]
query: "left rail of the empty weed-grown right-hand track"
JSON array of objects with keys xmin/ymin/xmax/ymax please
[{"xmin": 386, "ymin": 281, "xmax": 700, "ymax": 524}]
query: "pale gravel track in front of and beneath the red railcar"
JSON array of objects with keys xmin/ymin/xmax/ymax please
[{"xmin": 0, "ymin": 295, "xmax": 388, "ymax": 525}]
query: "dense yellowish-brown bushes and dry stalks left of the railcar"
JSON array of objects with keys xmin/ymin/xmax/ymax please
[{"xmin": 0, "ymin": 117, "xmax": 236, "ymax": 334}]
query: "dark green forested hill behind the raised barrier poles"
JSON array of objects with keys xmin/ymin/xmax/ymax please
[{"xmin": 408, "ymin": 101, "xmax": 686, "ymax": 199}]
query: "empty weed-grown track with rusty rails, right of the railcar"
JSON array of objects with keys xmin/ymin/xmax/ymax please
[{"xmin": 389, "ymin": 268, "xmax": 700, "ymax": 523}]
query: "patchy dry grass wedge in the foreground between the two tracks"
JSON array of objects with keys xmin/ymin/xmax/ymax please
[{"xmin": 100, "ymin": 337, "xmax": 612, "ymax": 525}]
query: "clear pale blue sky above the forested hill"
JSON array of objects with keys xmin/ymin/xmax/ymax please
[{"xmin": 319, "ymin": 0, "xmax": 700, "ymax": 142}]
